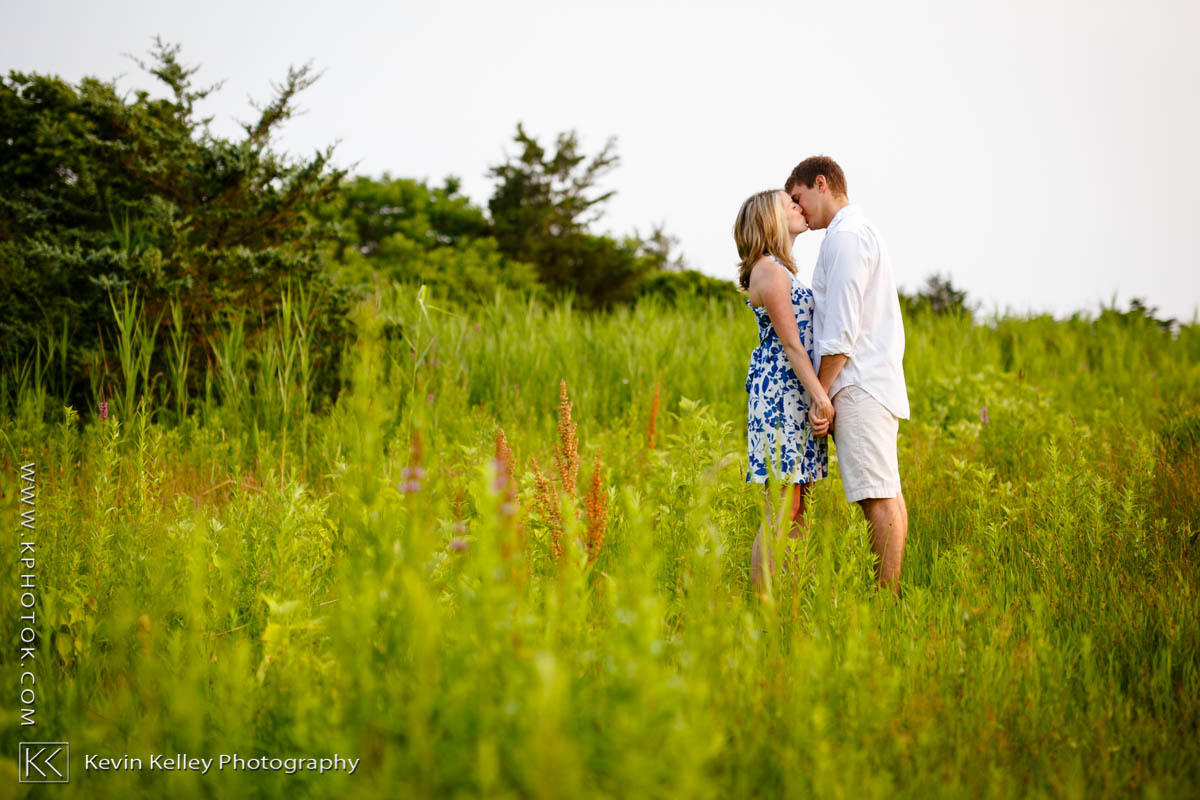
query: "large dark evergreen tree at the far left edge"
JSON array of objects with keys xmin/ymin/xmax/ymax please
[{"xmin": 0, "ymin": 40, "xmax": 347, "ymax": 407}]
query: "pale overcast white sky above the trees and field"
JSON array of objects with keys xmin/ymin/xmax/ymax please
[{"xmin": 0, "ymin": 0, "xmax": 1200, "ymax": 320}]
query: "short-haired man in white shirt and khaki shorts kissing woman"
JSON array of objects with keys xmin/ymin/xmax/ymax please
[{"xmin": 784, "ymin": 156, "xmax": 908, "ymax": 594}]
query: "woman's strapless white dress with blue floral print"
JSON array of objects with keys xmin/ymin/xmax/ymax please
[{"xmin": 746, "ymin": 257, "xmax": 829, "ymax": 483}]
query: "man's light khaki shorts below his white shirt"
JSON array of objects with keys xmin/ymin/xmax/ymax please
[{"xmin": 833, "ymin": 385, "xmax": 900, "ymax": 503}]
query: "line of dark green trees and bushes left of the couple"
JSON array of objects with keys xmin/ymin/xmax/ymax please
[{"xmin": 0, "ymin": 40, "xmax": 732, "ymax": 407}]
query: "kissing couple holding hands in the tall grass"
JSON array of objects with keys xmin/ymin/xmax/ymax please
[{"xmin": 733, "ymin": 156, "xmax": 908, "ymax": 594}]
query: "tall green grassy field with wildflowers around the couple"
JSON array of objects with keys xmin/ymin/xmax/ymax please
[{"xmin": 0, "ymin": 288, "xmax": 1200, "ymax": 798}]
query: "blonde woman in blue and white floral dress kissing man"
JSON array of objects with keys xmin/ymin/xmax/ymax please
[{"xmin": 733, "ymin": 190, "xmax": 834, "ymax": 591}]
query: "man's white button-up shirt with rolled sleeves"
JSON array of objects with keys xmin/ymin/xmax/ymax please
[{"xmin": 812, "ymin": 204, "xmax": 908, "ymax": 420}]
